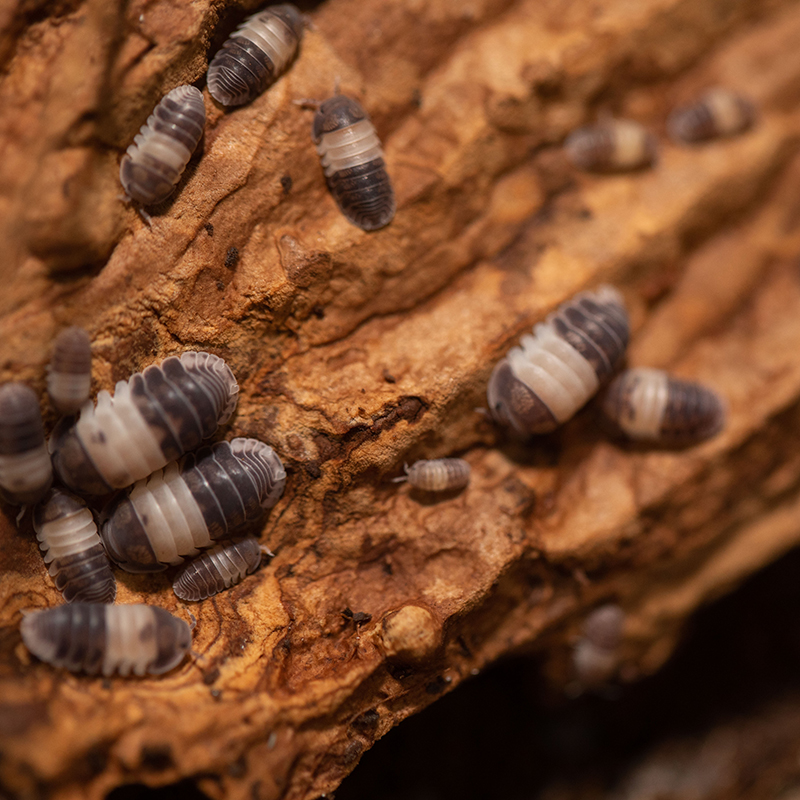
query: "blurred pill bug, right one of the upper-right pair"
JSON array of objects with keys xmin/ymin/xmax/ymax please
[{"xmin": 667, "ymin": 88, "xmax": 755, "ymax": 142}]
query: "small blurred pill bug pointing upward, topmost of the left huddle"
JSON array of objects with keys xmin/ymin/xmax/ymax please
[{"xmin": 47, "ymin": 325, "xmax": 92, "ymax": 414}]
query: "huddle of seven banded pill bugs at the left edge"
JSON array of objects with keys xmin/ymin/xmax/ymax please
[{"xmin": 0, "ymin": 328, "xmax": 286, "ymax": 675}]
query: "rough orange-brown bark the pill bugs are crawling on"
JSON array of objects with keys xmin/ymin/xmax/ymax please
[{"xmin": 0, "ymin": 0, "xmax": 800, "ymax": 799}]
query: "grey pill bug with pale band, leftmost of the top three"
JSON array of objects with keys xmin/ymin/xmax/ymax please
[{"xmin": 119, "ymin": 86, "xmax": 206, "ymax": 206}]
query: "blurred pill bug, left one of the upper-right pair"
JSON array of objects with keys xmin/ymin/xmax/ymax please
[{"xmin": 564, "ymin": 119, "xmax": 658, "ymax": 172}]
